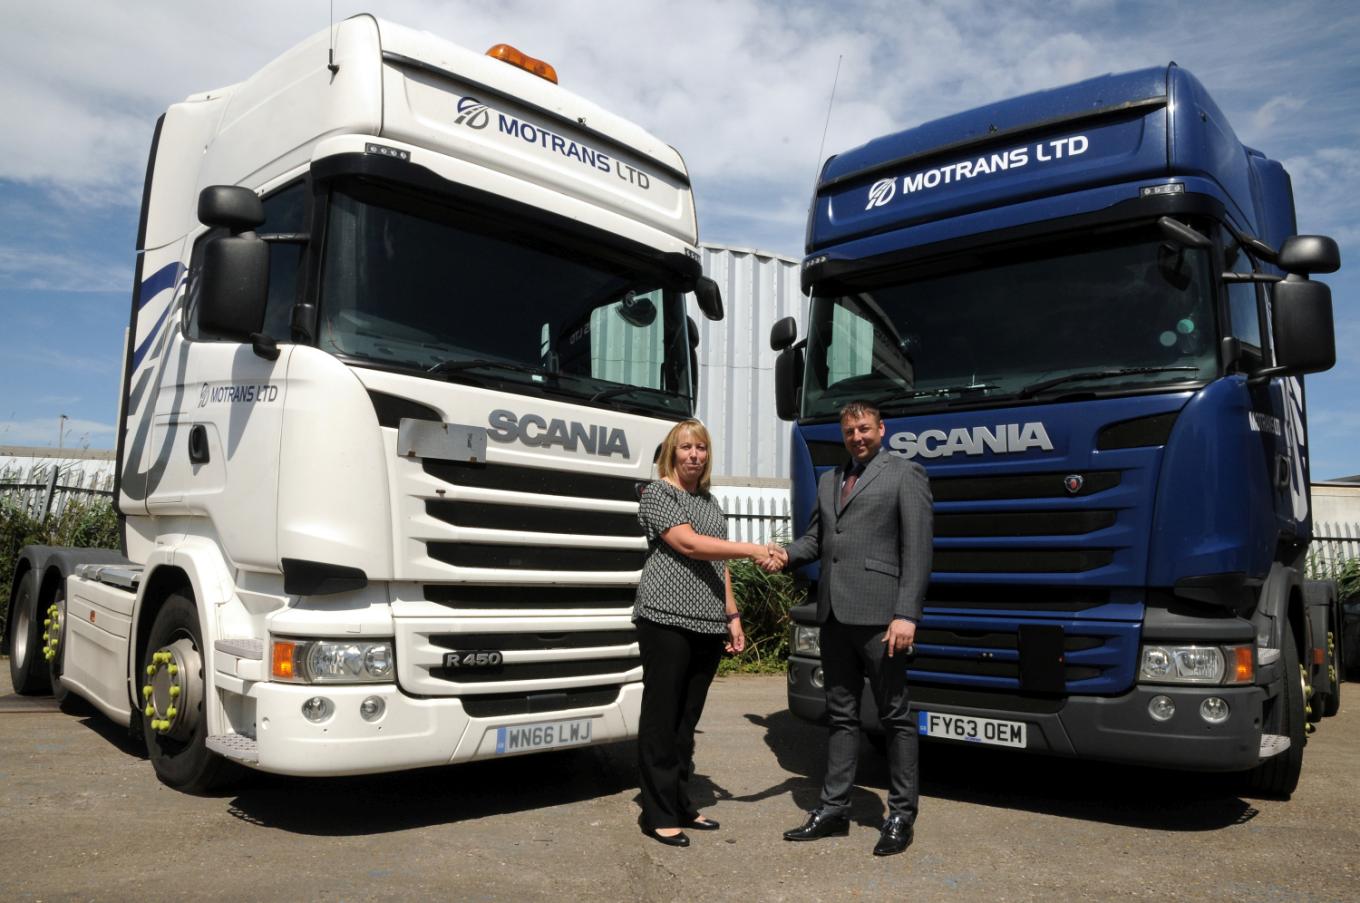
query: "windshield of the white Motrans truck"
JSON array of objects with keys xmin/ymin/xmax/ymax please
[{"xmin": 318, "ymin": 185, "xmax": 691, "ymax": 416}]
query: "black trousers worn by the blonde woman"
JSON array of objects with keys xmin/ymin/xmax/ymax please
[{"xmin": 636, "ymin": 617, "xmax": 724, "ymax": 828}]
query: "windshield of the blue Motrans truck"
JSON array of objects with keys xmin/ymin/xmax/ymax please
[{"xmin": 802, "ymin": 221, "xmax": 1217, "ymax": 419}]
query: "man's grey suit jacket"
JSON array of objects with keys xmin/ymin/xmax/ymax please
[{"xmin": 787, "ymin": 447, "xmax": 933, "ymax": 627}]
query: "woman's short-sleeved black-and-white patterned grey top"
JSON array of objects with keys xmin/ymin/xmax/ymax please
[{"xmin": 632, "ymin": 480, "xmax": 728, "ymax": 634}]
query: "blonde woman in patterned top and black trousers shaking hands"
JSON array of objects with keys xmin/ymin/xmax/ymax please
[{"xmin": 632, "ymin": 420, "xmax": 770, "ymax": 846}]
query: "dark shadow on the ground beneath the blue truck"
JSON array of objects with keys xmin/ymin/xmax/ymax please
[{"xmin": 743, "ymin": 711, "xmax": 1257, "ymax": 831}]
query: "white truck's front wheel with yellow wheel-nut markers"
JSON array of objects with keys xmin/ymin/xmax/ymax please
[{"xmin": 139, "ymin": 593, "xmax": 230, "ymax": 793}]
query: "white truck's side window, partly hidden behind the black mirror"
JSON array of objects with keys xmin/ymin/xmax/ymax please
[{"xmin": 184, "ymin": 182, "xmax": 307, "ymax": 341}]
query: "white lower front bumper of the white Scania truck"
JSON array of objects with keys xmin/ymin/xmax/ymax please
[{"xmin": 245, "ymin": 681, "xmax": 642, "ymax": 777}]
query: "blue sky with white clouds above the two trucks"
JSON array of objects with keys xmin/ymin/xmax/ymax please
[{"xmin": 0, "ymin": 0, "xmax": 1360, "ymax": 480}]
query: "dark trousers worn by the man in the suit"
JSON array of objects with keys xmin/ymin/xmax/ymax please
[{"xmin": 821, "ymin": 615, "xmax": 919, "ymax": 824}]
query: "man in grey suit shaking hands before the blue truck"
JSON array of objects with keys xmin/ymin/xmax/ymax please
[{"xmin": 768, "ymin": 401, "xmax": 932, "ymax": 855}]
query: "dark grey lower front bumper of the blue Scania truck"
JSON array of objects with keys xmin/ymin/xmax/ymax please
[{"xmin": 789, "ymin": 657, "xmax": 1265, "ymax": 771}]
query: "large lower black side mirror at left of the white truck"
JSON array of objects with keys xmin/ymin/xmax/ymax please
[{"xmin": 199, "ymin": 232, "xmax": 269, "ymax": 341}]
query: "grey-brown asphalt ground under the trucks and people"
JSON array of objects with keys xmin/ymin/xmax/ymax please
[{"xmin": 0, "ymin": 665, "xmax": 1360, "ymax": 903}]
